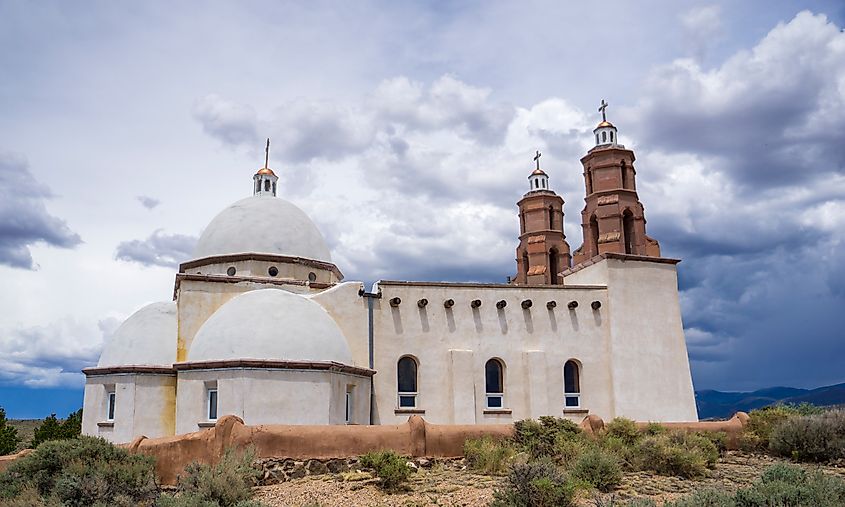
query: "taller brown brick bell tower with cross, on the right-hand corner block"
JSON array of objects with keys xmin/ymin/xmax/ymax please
[{"xmin": 573, "ymin": 100, "xmax": 660, "ymax": 264}]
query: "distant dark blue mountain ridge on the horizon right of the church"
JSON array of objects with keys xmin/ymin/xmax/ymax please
[{"xmin": 695, "ymin": 383, "xmax": 845, "ymax": 419}]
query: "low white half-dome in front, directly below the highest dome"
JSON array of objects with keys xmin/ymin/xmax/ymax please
[{"xmin": 188, "ymin": 289, "xmax": 352, "ymax": 365}]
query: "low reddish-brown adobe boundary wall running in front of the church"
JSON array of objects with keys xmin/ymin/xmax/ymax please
[{"xmin": 0, "ymin": 412, "xmax": 748, "ymax": 485}]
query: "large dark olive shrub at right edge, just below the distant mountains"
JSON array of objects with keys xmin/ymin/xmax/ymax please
[{"xmin": 769, "ymin": 411, "xmax": 845, "ymax": 462}]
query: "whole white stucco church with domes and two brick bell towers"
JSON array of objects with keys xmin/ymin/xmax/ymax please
[{"xmin": 82, "ymin": 111, "xmax": 697, "ymax": 442}]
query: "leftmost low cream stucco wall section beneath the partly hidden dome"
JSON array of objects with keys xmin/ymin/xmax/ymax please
[{"xmin": 82, "ymin": 373, "xmax": 176, "ymax": 443}]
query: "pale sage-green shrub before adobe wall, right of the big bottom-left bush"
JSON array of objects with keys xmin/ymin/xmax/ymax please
[{"xmin": 170, "ymin": 448, "xmax": 260, "ymax": 507}]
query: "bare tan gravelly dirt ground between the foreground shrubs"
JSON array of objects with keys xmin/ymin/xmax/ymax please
[{"xmin": 256, "ymin": 452, "xmax": 845, "ymax": 507}]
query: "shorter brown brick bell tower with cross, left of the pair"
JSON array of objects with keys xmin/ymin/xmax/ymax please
[{"xmin": 515, "ymin": 151, "xmax": 571, "ymax": 285}]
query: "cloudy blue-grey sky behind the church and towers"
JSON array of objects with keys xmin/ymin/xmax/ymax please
[{"xmin": 0, "ymin": 0, "xmax": 845, "ymax": 416}]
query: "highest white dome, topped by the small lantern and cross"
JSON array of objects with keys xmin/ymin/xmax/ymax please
[{"xmin": 194, "ymin": 195, "xmax": 331, "ymax": 262}]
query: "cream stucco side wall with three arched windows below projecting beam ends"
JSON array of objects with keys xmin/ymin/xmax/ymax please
[{"xmin": 362, "ymin": 283, "xmax": 613, "ymax": 424}]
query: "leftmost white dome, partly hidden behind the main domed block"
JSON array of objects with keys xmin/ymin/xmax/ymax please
[{"xmin": 97, "ymin": 301, "xmax": 177, "ymax": 368}]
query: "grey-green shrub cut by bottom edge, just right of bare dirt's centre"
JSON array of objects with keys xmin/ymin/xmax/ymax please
[{"xmin": 490, "ymin": 459, "xmax": 577, "ymax": 507}]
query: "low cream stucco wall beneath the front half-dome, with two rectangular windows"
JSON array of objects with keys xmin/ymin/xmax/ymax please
[{"xmin": 176, "ymin": 368, "xmax": 370, "ymax": 433}]
